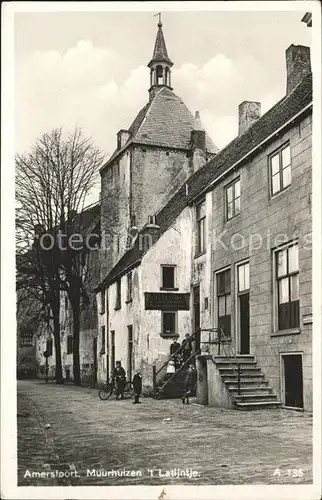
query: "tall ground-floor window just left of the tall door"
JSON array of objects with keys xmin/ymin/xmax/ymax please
[{"xmin": 217, "ymin": 269, "xmax": 231, "ymax": 336}]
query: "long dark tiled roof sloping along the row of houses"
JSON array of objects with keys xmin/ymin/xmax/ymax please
[{"xmin": 99, "ymin": 75, "xmax": 312, "ymax": 288}]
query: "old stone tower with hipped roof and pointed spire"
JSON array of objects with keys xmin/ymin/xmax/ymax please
[{"xmin": 100, "ymin": 18, "xmax": 218, "ymax": 277}]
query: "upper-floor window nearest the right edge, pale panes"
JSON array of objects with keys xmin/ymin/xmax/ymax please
[{"xmin": 270, "ymin": 144, "xmax": 291, "ymax": 195}]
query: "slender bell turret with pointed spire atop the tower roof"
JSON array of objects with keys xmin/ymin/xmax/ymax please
[{"xmin": 148, "ymin": 14, "xmax": 173, "ymax": 100}]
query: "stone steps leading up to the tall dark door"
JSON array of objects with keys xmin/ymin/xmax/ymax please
[{"xmin": 213, "ymin": 354, "xmax": 282, "ymax": 410}]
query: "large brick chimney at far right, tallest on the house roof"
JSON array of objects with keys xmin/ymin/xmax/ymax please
[{"xmin": 285, "ymin": 45, "xmax": 311, "ymax": 94}]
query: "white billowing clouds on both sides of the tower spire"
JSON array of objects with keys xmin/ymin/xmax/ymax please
[{"xmin": 16, "ymin": 40, "xmax": 279, "ymax": 159}]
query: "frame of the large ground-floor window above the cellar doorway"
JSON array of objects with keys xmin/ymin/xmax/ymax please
[{"xmin": 272, "ymin": 240, "xmax": 301, "ymax": 335}]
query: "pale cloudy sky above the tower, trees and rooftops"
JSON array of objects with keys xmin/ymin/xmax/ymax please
[{"xmin": 14, "ymin": 11, "xmax": 311, "ymax": 179}]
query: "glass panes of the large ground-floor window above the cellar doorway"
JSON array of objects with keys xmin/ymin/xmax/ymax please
[{"xmin": 276, "ymin": 243, "xmax": 300, "ymax": 330}]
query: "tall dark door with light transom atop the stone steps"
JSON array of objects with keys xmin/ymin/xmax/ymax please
[{"xmin": 237, "ymin": 262, "xmax": 250, "ymax": 354}]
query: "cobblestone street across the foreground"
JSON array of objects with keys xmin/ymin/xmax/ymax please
[{"xmin": 18, "ymin": 381, "xmax": 312, "ymax": 486}]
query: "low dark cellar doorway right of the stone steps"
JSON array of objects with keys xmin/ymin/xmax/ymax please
[{"xmin": 282, "ymin": 354, "xmax": 303, "ymax": 408}]
